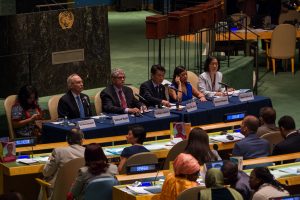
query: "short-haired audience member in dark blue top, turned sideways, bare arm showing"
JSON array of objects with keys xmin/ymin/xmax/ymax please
[{"xmin": 118, "ymin": 125, "xmax": 149, "ymax": 172}]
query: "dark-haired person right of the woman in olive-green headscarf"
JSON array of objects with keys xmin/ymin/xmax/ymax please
[{"xmin": 221, "ymin": 160, "xmax": 252, "ymax": 200}]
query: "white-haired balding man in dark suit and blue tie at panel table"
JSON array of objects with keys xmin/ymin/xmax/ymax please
[{"xmin": 57, "ymin": 74, "xmax": 92, "ymax": 119}]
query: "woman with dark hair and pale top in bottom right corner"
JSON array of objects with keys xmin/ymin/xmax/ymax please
[{"xmin": 249, "ymin": 167, "xmax": 289, "ymax": 200}]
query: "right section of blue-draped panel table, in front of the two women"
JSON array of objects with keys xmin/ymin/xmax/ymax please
[{"xmin": 171, "ymin": 96, "xmax": 272, "ymax": 126}]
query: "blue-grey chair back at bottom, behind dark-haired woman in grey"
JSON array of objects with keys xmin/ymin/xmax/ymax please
[{"xmin": 84, "ymin": 177, "xmax": 118, "ymax": 200}]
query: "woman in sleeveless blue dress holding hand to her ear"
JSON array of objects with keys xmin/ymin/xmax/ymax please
[{"xmin": 169, "ymin": 66, "xmax": 206, "ymax": 102}]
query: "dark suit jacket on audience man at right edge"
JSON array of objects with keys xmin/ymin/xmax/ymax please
[{"xmin": 273, "ymin": 131, "xmax": 300, "ymax": 155}]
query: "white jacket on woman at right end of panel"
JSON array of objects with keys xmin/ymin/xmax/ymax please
[{"xmin": 199, "ymin": 72, "xmax": 224, "ymax": 97}]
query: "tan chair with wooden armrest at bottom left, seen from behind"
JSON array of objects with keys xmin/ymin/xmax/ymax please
[{"xmin": 35, "ymin": 158, "xmax": 85, "ymax": 200}]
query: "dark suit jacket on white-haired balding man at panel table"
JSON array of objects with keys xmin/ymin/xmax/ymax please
[{"xmin": 57, "ymin": 90, "xmax": 92, "ymax": 119}]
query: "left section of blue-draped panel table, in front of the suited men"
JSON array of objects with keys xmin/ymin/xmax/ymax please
[{"xmin": 42, "ymin": 112, "xmax": 179, "ymax": 143}]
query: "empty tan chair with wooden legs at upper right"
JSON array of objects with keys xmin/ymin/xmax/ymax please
[{"xmin": 267, "ymin": 24, "xmax": 296, "ymax": 76}]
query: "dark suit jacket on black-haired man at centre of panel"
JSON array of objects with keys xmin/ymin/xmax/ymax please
[{"xmin": 140, "ymin": 80, "xmax": 167, "ymax": 107}]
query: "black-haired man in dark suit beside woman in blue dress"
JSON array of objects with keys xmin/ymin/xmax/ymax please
[{"xmin": 140, "ymin": 65, "xmax": 170, "ymax": 107}]
